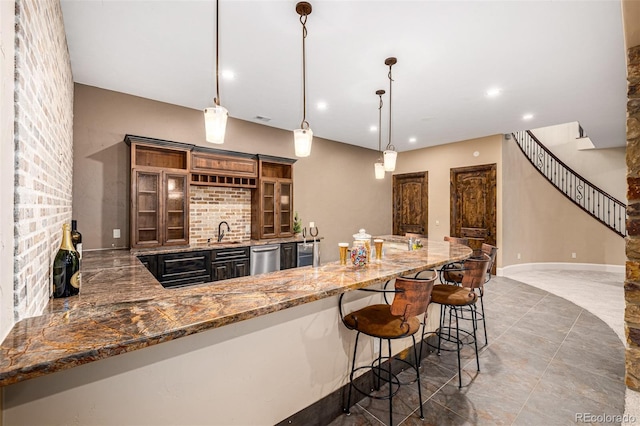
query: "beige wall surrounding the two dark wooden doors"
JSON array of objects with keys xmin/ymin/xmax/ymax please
[{"xmin": 394, "ymin": 135, "xmax": 503, "ymax": 266}]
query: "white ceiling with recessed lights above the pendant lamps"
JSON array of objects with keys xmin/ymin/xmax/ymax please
[{"xmin": 62, "ymin": 0, "xmax": 627, "ymax": 151}]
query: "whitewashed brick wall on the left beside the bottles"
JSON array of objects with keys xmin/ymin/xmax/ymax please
[{"xmin": 14, "ymin": 0, "xmax": 73, "ymax": 321}]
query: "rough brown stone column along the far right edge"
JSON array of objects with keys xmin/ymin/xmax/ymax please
[{"xmin": 624, "ymin": 46, "xmax": 640, "ymax": 391}]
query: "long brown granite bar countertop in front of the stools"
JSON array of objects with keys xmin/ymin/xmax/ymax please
[{"xmin": 0, "ymin": 236, "xmax": 471, "ymax": 386}]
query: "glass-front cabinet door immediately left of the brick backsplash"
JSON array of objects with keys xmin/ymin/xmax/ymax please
[{"xmin": 164, "ymin": 173, "xmax": 189, "ymax": 245}]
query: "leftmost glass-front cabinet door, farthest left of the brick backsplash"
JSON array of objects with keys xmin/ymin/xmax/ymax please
[{"xmin": 132, "ymin": 171, "xmax": 162, "ymax": 246}]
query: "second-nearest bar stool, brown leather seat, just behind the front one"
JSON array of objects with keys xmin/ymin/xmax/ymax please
[{"xmin": 422, "ymin": 254, "xmax": 490, "ymax": 387}]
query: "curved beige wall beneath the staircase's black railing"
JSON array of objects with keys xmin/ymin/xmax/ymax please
[{"xmin": 501, "ymin": 139, "xmax": 625, "ymax": 266}]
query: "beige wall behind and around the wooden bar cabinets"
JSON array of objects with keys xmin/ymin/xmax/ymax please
[{"xmin": 73, "ymin": 84, "xmax": 391, "ymax": 261}]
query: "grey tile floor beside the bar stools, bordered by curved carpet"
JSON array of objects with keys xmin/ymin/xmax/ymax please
[{"xmin": 331, "ymin": 273, "xmax": 625, "ymax": 426}]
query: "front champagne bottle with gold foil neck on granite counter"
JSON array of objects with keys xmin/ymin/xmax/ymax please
[{"xmin": 53, "ymin": 223, "xmax": 80, "ymax": 298}]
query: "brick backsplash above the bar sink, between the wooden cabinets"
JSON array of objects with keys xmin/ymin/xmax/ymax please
[{"xmin": 189, "ymin": 185, "xmax": 251, "ymax": 245}]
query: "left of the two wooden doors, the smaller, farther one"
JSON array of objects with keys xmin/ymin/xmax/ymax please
[{"xmin": 393, "ymin": 172, "xmax": 429, "ymax": 235}]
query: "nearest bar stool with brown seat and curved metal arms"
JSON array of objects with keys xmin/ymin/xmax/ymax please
[{"xmin": 340, "ymin": 273, "xmax": 436, "ymax": 425}]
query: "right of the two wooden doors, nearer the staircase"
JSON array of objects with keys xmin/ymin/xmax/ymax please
[{"xmin": 450, "ymin": 164, "xmax": 497, "ymax": 253}]
